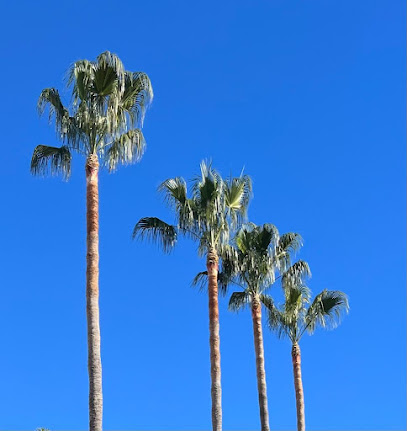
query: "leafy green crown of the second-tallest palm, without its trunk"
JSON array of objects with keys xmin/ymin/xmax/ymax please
[{"xmin": 133, "ymin": 162, "xmax": 251, "ymax": 256}]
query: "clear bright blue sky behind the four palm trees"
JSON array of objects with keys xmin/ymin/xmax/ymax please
[{"xmin": 0, "ymin": 0, "xmax": 406, "ymax": 430}]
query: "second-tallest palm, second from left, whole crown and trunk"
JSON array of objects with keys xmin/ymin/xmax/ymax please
[{"xmin": 133, "ymin": 162, "xmax": 251, "ymax": 431}]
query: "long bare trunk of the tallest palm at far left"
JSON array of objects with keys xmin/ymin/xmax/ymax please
[{"xmin": 85, "ymin": 154, "xmax": 103, "ymax": 431}]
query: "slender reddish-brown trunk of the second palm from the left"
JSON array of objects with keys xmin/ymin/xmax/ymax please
[{"xmin": 206, "ymin": 249, "xmax": 222, "ymax": 431}]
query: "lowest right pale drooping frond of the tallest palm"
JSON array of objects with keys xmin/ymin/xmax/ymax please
[{"xmin": 104, "ymin": 129, "xmax": 145, "ymax": 171}]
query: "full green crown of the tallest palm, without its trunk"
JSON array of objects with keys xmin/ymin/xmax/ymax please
[{"xmin": 31, "ymin": 51, "xmax": 153, "ymax": 179}]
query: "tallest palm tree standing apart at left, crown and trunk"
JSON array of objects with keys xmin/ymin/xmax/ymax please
[{"xmin": 31, "ymin": 51, "xmax": 153, "ymax": 431}]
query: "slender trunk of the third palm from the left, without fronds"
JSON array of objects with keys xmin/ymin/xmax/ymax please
[{"xmin": 252, "ymin": 298, "xmax": 270, "ymax": 431}]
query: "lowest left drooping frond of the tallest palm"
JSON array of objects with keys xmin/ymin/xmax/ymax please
[{"xmin": 31, "ymin": 145, "xmax": 72, "ymax": 180}]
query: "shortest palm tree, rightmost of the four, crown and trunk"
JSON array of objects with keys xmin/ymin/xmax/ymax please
[{"xmin": 267, "ymin": 261, "xmax": 349, "ymax": 431}]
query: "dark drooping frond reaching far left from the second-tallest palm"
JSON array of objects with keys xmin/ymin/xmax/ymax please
[{"xmin": 133, "ymin": 217, "xmax": 177, "ymax": 253}]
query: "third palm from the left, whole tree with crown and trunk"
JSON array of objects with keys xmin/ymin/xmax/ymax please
[{"xmin": 210, "ymin": 223, "xmax": 302, "ymax": 431}]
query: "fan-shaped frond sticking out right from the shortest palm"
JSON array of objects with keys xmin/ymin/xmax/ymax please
[{"xmin": 305, "ymin": 289, "xmax": 349, "ymax": 334}]
